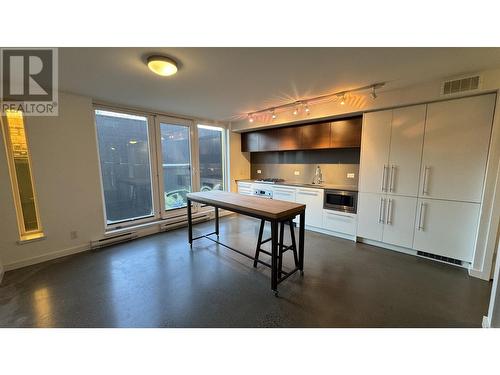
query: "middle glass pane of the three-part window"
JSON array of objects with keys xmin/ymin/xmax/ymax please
[{"xmin": 160, "ymin": 122, "xmax": 192, "ymax": 210}]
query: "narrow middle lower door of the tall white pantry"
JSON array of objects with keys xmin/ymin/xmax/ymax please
[{"xmin": 382, "ymin": 195, "xmax": 417, "ymax": 248}]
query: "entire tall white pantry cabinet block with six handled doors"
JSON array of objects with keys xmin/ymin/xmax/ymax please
[{"xmin": 357, "ymin": 94, "xmax": 495, "ymax": 263}]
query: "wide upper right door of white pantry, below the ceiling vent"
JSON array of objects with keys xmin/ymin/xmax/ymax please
[{"xmin": 418, "ymin": 94, "xmax": 495, "ymax": 203}]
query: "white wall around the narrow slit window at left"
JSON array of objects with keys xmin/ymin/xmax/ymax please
[{"xmin": 0, "ymin": 93, "xmax": 104, "ymax": 270}]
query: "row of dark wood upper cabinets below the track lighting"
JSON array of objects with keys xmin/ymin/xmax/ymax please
[{"xmin": 241, "ymin": 117, "xmax": 362, "ymax": 152}]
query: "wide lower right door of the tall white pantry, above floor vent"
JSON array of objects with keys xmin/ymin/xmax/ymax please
[{"xmin": 413, "ymin": 199, "xmax": 480, "ymax": 262}]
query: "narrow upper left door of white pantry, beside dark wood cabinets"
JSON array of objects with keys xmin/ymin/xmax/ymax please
[{"xmin": 359, "ymin": 110, "xmax": 392, "ymax": 193}]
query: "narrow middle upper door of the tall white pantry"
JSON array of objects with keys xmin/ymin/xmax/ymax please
[{"xmin": 387, "ymin": 104, "xmax": 426, "ymax": 197}]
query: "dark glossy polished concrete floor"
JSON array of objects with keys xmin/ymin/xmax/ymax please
[{"xmin": 0, "ymin": 215, "xmax": 490, "ymax": 327}]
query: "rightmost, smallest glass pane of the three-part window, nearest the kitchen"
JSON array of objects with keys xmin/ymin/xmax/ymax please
[{"xmin": 198, "ymin": 125, "xmax": 225, "ymax": 191}]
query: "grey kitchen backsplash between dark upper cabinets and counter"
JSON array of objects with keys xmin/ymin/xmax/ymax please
[{"xmin": 250, "ymin": 148, "xmax": 360, "ymax": 186}]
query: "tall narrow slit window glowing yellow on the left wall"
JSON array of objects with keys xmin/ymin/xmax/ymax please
[{"xmin": 3, "ymin": 111, "xmax": 43, "ymax": 240}]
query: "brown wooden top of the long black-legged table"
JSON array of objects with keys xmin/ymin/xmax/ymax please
[{"xmin": 187, "ymin": 190, "xmax": 306, "ymax": 220}]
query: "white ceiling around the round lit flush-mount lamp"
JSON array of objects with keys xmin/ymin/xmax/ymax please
[{"xmin": 59, "ymin": 48, "xmax": 500, "ymax": 121}]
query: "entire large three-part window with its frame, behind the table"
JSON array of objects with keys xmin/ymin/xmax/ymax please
[{"xmin": 95, "ymin": 107, "xmax": 227, "ymax": 229}]
